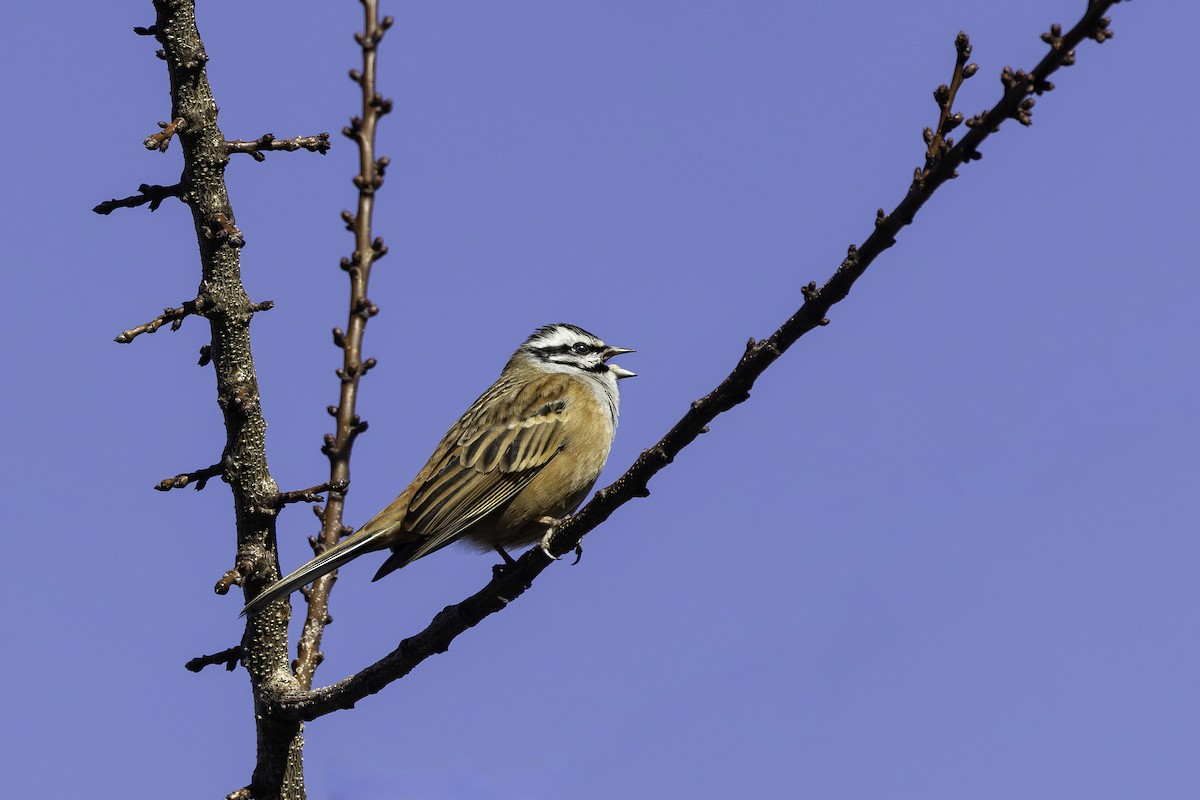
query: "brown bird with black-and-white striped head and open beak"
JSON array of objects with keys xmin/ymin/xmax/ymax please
[{"xmin": 241, "ymin": 323, "xmax": 637, "ymax": 615}]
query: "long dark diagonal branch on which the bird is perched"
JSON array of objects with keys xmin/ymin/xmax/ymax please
[{"xmin": 266, "ymin": 0, "xmax": 1116, "ymax": 721}]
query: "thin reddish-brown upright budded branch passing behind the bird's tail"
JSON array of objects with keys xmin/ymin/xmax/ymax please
[{"xmin": 293, "ymin": 0, "xmax": 392, "ymax": 690}]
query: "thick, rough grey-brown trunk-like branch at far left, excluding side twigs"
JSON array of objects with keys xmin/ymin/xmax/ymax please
[{"xmin": 144, "ymin": 0, "xmax": 305, "ymax": 800}]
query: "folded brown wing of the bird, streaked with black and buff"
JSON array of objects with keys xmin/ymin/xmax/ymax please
[{"xmin": 393, "ymin": 374, "xmax": 570, "ymax": 561}]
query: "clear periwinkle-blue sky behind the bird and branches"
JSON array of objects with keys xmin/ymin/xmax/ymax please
[{"xmin": 0, "ymin": 0, "xmax": 1200, "ymax": 800}]
